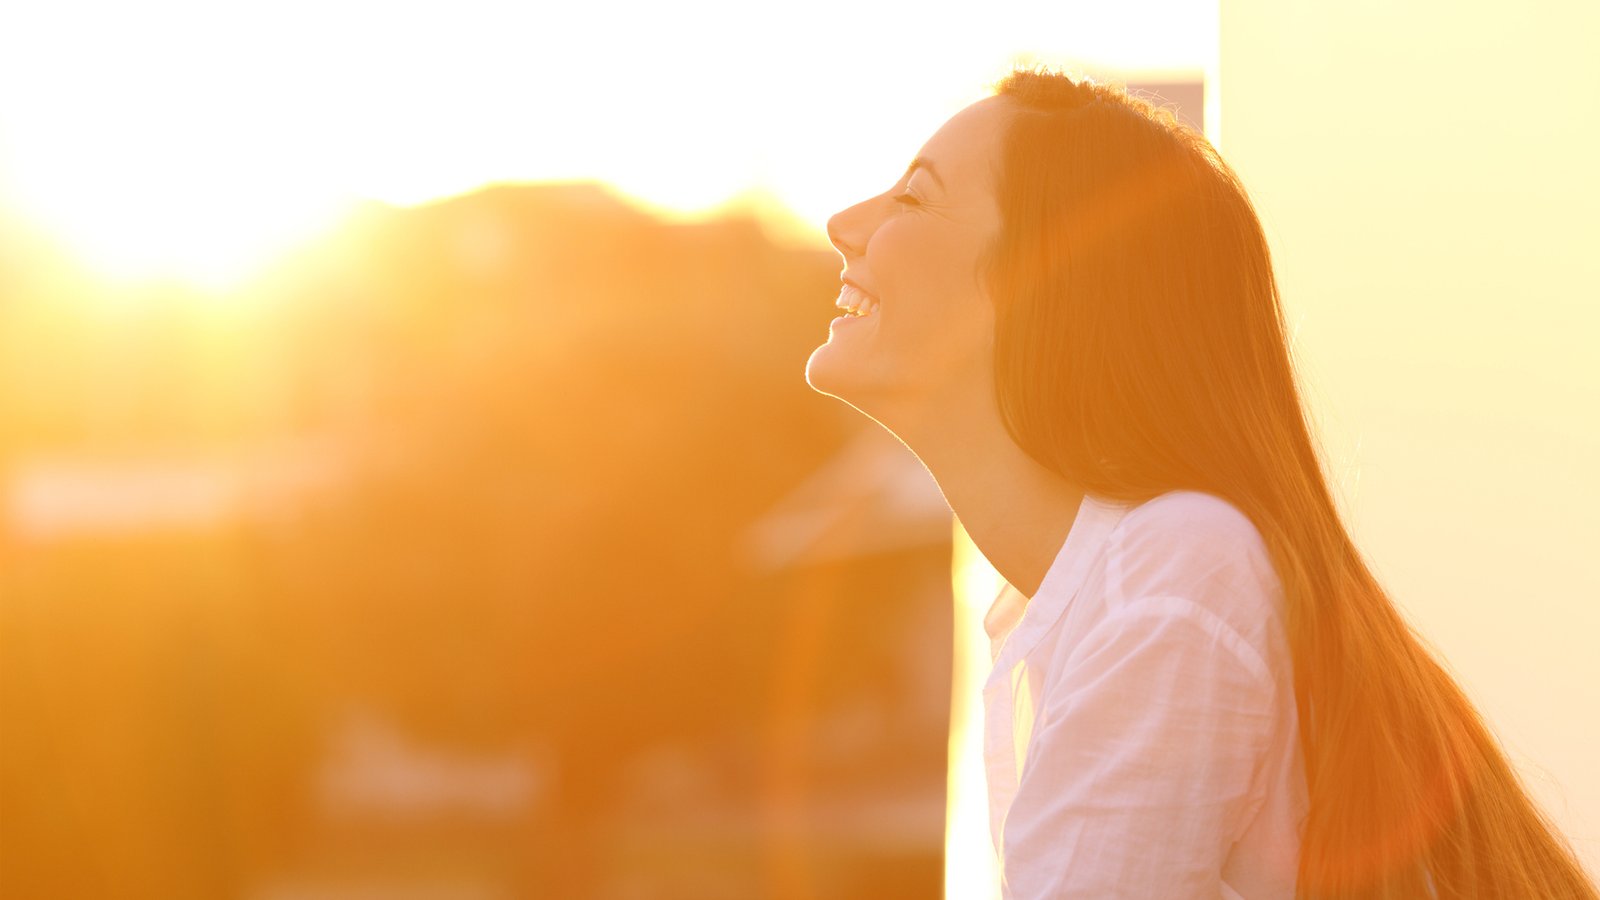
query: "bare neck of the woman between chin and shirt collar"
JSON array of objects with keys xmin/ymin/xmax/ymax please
[{"xmin": 878, "ymin": 376, "xmax": 1083, "ymax": 599}]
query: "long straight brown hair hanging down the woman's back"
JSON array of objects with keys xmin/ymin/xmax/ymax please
[{"xmin": 984, "ymin": 69, "xmax": 1597, "ymax": 900}]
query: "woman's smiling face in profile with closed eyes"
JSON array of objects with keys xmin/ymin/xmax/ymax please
[{"xmin": 806, "ymin": 96, "xmax": 1010, "ymax": 424}]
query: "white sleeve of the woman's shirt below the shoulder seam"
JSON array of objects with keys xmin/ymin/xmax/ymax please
[{"xmin": 1000, "ymin": 596, "xmax": 1275, "ymax": 900}]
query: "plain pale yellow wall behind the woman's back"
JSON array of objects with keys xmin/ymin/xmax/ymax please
[{"xmin": 1218, "ymin": 0, "xmax": 1600, "ymax": 873}]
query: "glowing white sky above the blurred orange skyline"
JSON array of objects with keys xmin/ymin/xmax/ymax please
[{"xmin": 0, "ymin": 0, "xmax": 1216, "ymax": 283}]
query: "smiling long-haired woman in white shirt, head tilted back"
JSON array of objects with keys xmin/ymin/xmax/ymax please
[{"xmin": 806, "ymin": 70, "xmax": 1597, "ymax": 900}]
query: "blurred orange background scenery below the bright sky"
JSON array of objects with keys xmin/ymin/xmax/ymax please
[{"xmin": 0, "ymin": 184, "xmax": 949, "ymax": 898}]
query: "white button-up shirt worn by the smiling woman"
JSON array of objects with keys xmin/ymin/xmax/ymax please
[{"xmin": 984, "ymin": 490, "xmax": 1307, "ymax": 900}]
